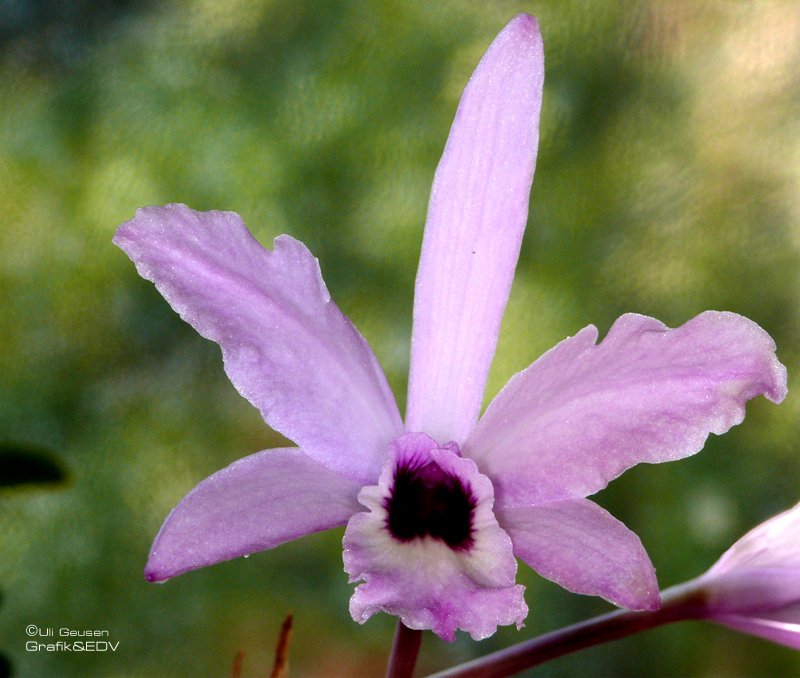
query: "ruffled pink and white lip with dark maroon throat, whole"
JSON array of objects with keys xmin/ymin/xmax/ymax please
[{"xmin": 343, "ymin": 432, "xmax": 528, "ymax": 641}]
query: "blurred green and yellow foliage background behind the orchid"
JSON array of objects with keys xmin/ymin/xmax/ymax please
[{"xmin": 0, "ymin": 0, "xmax": 800, "ymax": 676}]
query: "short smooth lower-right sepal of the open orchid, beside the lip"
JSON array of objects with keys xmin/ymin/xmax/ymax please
[{"xmin": 495, "ymin": 499, "xmax": 659, "ymax": 610}]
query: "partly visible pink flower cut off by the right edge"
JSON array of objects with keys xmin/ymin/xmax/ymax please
[{"xmin": 687, "ymin": 504, "xmax": 800, "ymax": 650}]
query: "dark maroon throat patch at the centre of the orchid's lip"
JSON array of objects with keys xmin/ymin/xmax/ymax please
[{"xmin": 384, "ymin": 446, "xmax": 477, "ymax": 551}]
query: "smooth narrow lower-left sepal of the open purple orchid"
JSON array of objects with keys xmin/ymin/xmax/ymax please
[{"xmin": 145, "ymin": 448, "xmax": 362, "ymax": 581}]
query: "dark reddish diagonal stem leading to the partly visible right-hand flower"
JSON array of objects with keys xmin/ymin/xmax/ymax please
[{"xmin": 430, "ymin": 580, "xmax": 705, "ymax": 678}]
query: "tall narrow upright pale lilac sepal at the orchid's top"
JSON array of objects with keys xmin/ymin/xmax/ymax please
[{"xmin": 406, "ymin": 15, "xmax": 544, "ymax": 444}]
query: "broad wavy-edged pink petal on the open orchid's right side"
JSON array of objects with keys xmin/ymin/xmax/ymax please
[{"xmin": 463, "ymin": 311, "xmax": 786, "ymax": 506}]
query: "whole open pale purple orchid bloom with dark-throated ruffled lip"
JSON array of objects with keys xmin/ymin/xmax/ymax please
[{"xmin": 114, "ymin": 15, "xmax": 786, "ymax": 640}]
